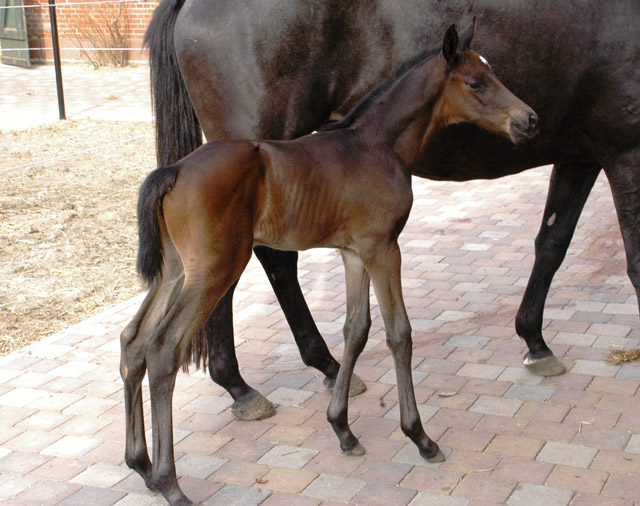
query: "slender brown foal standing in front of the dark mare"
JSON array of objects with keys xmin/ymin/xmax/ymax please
[{"xmin": 121, "ymin": 26, "xmax": 537, "ymax": 504}]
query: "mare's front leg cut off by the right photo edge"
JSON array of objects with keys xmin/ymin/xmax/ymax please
[{"xmin": 605, "ymin": 149, "xmax": 640, "ymax": 314}]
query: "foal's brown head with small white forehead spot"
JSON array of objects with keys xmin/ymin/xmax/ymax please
[{"xmin": 436, "ymin": 20, "xmax": 538, "ymax": 143}]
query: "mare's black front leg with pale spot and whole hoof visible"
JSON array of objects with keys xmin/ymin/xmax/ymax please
[{"xmin": 516, "ymin": 163, "xmax": 600, "ymax": 376}]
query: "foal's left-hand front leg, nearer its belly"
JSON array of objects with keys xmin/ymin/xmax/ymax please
[{"xmin": 327, "ymin": 251, "xmax": 371, "ymax": 455}]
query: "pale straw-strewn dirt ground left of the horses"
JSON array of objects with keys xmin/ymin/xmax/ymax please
[{"xmin": 0, "ymin": 120, "xmax": 155, "ymax": 355}]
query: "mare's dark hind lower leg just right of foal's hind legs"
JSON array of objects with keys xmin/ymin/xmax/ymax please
[{"xmin": 204, "ymin": 282, "xmax": 276, "ymax": 420}]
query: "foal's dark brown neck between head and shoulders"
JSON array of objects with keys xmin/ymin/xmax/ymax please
[{"xmin": 354, "ymin": 55, "xmax": 446, "ymax": 170}]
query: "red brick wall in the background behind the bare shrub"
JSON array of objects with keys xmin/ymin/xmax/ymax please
[{"xmin": 25, "ymin": 0, "xmax": 160, "ymax": 62}]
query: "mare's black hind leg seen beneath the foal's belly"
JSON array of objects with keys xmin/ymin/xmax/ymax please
[{"xmin": 253, "ymin": 246, "xmax": 367, "ymax": 396}]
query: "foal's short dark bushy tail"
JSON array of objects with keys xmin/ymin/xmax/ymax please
[{"xmin": 137, "ymin": 165, "xmax": 179, "ymax": 285}]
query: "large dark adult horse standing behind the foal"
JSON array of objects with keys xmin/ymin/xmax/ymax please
[{"xmin": 147, "ymin": 0, "xmax": 640, "ymax": 418}]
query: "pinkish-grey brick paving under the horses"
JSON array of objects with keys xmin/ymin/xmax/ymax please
[{"xmin": 0, "ymin": 64, "xmax": 640, "ymax": 506}]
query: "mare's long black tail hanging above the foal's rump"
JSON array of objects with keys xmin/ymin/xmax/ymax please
[{"xmin": 144, "ymin": 0, "xmax": 202, "ymax": 167}]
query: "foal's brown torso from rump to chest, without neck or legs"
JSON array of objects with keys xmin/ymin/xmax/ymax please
[{"xmin": 164, "ymin": 130, "xmax": 412, "ymax": 255}]
